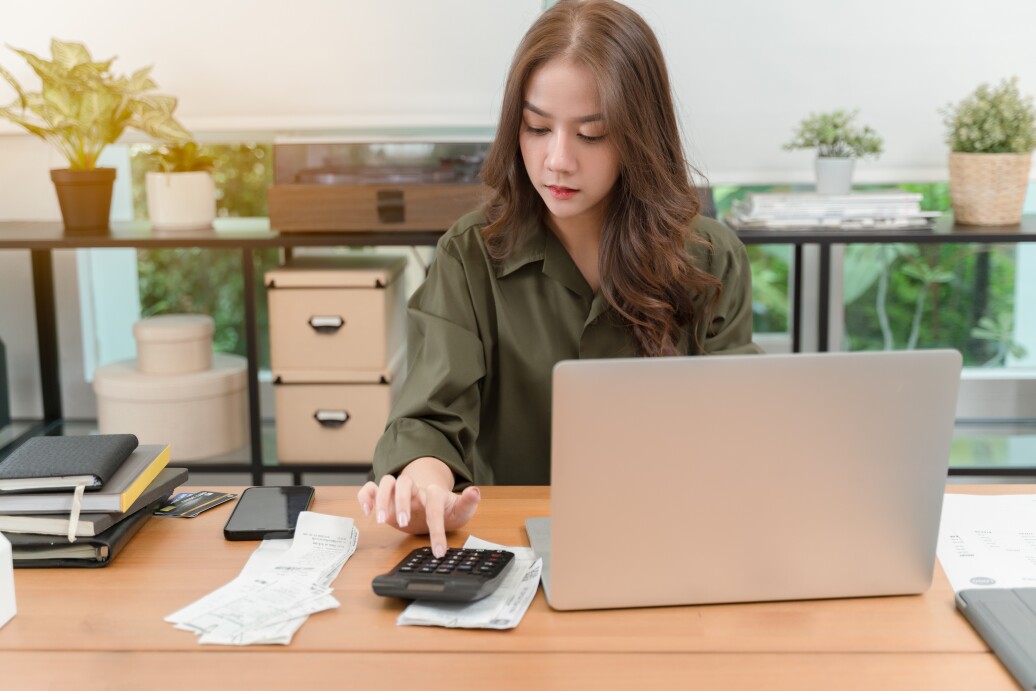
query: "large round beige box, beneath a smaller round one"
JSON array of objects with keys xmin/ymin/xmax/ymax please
[{"xmin": 93, "ymin": 353, "xmax": 248, "ymax": 461}]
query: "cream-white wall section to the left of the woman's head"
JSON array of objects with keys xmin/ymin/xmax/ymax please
[{"xmin": 0, "ymin": 0, "xmax": 542, "ymax": 131}]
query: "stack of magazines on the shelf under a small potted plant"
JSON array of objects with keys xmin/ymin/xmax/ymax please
[{"xmin": 727, "ymin": 190, "xmax": 941, "ymax": 230}]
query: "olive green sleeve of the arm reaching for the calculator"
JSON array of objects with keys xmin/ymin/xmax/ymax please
[{"xmin": 373, "ymin": 238, "xmax": 486, "ymax": 484}]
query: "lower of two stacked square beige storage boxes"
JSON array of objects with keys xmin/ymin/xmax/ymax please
[{"xmin": 274, "ymin": 366, "xmax": 402, "ymax": 465}]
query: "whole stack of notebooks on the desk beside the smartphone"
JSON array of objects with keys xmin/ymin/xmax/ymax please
[{"xmin": 0, "ymin": 434, "xmax": 188, "ymax": 567}]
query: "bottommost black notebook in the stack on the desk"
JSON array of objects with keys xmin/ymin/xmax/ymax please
[{"xmin": 4, "ymin": 499, "xmax": 163, "ymax": 569}]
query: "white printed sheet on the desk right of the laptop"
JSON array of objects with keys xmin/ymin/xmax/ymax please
[{"xmin": 937, "ymin": 494, "xmax": 1036, "ymax": 593}]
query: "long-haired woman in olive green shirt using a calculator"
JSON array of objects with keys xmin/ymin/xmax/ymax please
[{"xmin": 358, "ymin": 0, "xmax": 757, "ymax": 555}]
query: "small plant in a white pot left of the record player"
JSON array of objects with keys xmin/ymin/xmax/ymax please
[{"xmin": 145, "ymin": 141, "xmax": 215, "ymax": 230}]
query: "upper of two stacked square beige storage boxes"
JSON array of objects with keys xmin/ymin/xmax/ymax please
[{"xmin": 264, "ymin": 254, "xmax": 406, "ymax": 382}]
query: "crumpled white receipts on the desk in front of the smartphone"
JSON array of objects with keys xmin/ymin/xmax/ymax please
[{"xmin": 166, "ymin": 511, "xmax": 359, "ymax": 645}]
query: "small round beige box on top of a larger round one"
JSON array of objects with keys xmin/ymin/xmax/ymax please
[{"xmin": 133, "ymin": 314, "xmax": 214, "ymax": 375}]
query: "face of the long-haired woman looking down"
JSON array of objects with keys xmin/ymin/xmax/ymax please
[{"xmin": 518, "ymin": 59, "xmax": 618, "ymax": 235}]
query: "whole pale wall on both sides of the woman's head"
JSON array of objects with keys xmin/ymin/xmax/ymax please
[{"xmin": 0, "ymin": 0, "xmax": 1036, "ymax": 183}]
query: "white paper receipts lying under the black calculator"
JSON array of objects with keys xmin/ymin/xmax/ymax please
[{"xmin": 396, "ymin": 537, "xmax": 543, "ymax": 629}]
